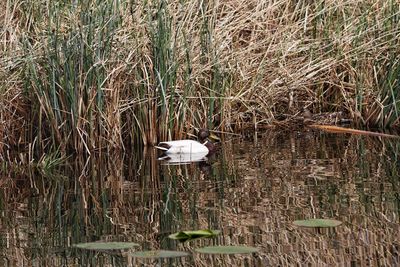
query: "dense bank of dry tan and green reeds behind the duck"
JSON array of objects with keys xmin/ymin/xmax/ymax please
[{"xmin": 0, "ymin": 0, "xmax": 400, "ymax": 154}]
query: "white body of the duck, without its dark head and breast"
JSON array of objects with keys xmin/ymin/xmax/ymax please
[{"xmin": 157, "ymin": 140, "xmax": 209, "ymax": 154}]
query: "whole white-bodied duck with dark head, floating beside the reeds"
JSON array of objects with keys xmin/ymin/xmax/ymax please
[{"xmin": 156, "ymin": 129, "xmax": 215, "ymax": 155}]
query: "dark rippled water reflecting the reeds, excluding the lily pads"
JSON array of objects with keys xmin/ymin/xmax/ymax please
[{"xmin": 0, "ymin": 132, "xmax": 400, "ymax": 266}]
